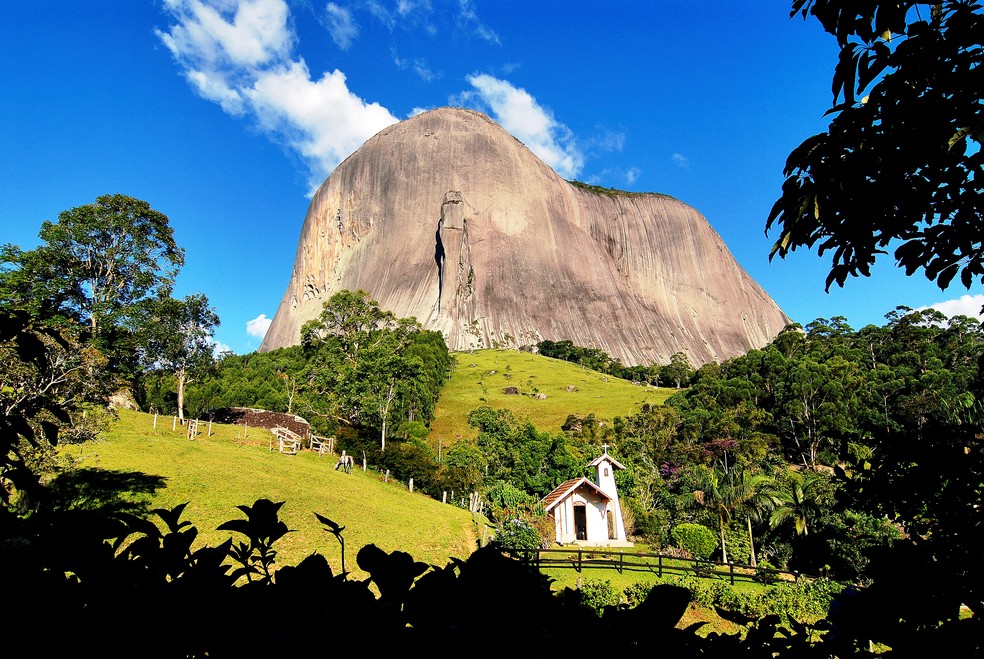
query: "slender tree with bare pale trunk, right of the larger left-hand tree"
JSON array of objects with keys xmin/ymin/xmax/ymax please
[{"xmin": 141, "ymin": 293, "xmax": 219, "ymax": 422}]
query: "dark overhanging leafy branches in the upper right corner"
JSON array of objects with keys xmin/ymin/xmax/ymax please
[{"xmin": 767, "ymin": 0, "xmax": 984, "ymax": 289}]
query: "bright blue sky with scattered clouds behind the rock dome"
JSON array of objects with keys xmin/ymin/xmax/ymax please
[{"xmin": 0, "ymin": 0, "xmax": 984, "ymax": 353}]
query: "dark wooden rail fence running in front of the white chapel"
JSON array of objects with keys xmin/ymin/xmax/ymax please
[{"xmin": 510, "ymin": 547, "xmax": 805, "ymax": 584}]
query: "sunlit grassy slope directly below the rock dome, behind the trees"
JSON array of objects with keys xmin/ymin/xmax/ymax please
[{"xmin": 430, "ymin": 350, "xmax": 676, "ymax": 446}]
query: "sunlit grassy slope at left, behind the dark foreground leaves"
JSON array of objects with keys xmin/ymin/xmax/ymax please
[{"xmin": 61, "ymin": 410, "xmax": 482, "ymax": 579}]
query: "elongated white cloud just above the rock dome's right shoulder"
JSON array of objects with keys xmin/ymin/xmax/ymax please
[{"xmin": 462, "ymin": 74, "xmax": 584, "ymax": 178}]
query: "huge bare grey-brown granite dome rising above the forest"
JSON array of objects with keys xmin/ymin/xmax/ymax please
[{"xmin": 260, "ymin": 108, "xmax": 789, "ymax": 365}]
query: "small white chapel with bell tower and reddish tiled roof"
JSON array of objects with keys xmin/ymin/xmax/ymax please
[{"xmin": 542, "ymin": 444, "xmax": 632, "ymax": 547}]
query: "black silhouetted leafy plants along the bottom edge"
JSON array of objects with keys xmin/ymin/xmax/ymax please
[{"xmin": 0, "ymin": 499, "xmax": 982, "ymax": 658}]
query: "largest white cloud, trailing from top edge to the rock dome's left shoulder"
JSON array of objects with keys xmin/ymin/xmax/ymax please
[{"xmin": 157, "ymin": 0, "xmax": 397, "ymax": 193}]
